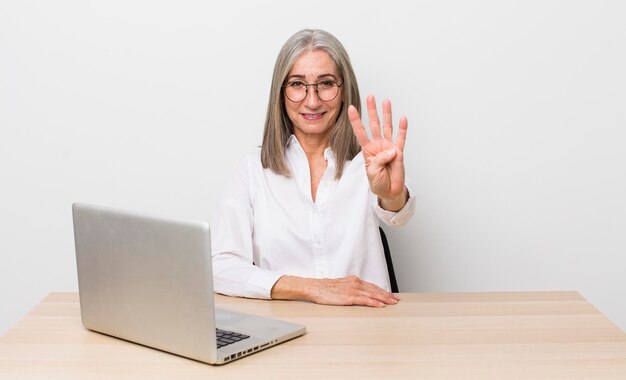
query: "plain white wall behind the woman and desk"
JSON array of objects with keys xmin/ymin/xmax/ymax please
[{"xmin": 0, "ymin": 0, "xmax": 626, "ymax": 334}]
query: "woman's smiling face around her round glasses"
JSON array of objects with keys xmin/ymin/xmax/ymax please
[{"xmin": 283, "ymin": 50, "xmax": 343, "ymax": 143}]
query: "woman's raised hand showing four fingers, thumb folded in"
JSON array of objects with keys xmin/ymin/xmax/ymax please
[{"xmin": 348, "ymin": 95, "xmax": 408, "ymax": 211}]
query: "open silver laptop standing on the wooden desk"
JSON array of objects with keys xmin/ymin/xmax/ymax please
[{"xmin": 72, "ymin": 203, "xmax": 306, "ymax": 364}]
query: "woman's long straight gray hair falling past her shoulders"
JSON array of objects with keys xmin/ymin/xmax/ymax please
[{"xmin": 261, "ymin": 29, "xmax": 361, "ymax": 179}]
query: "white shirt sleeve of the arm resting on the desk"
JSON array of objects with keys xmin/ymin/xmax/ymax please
[{"xmin": 211, "ymin": 156, "xmax": 283, "ymax": 299}]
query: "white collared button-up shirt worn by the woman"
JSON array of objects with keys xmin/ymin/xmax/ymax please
[{"xmin": 211, "ymin": 135, "xmax": 415, "ymax": 298}]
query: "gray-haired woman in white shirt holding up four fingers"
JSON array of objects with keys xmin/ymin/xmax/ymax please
[{"xmin": 211, "ymin": 30, "xmax": 414, "ymax": 307}]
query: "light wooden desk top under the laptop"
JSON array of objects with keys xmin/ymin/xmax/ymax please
[{"xmin": 0, "ymin": 292, "xmax": 626, "ymax": 380}]
